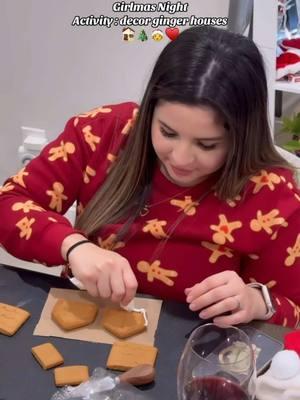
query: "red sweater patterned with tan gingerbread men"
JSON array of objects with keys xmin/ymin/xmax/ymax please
[{"xmin": 0, "ymin": 103, "xmax": 300, "ymax": 326}]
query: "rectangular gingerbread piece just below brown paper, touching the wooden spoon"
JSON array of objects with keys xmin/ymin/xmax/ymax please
[{"xmin": 106, "ymin": 342, "xmax": 157, "ymax": 371}]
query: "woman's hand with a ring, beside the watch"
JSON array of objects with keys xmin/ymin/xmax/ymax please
[{"xmin": 185, "ymin": 271, "xmax": 267, "ymax": 326}]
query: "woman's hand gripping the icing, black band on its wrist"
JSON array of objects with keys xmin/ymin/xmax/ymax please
[{"xmin": 62, "ymin": 235, "xmax": 138, "ymax": 306}]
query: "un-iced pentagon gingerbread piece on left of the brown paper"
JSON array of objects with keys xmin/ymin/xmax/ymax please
[{"xmin": 51, "ymin": 299, "xmax": 98, "ymax": 331}]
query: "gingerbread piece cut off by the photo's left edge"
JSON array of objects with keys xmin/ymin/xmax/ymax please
[{"xmin": 0, "ymin": 303, "xmax": 30, "ymax": 336}]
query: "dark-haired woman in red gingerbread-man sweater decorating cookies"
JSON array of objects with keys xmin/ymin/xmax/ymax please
[{"xmin": 0, "ymin": 27, "xmax": 300, "ymax": 326}]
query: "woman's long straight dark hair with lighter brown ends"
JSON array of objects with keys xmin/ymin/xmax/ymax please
[{"xmin": 76, "ymin": 27, "xmax": 291, "ymax": 235}]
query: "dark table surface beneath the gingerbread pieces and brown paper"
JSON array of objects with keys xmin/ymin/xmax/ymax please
[{"xmin": 0, "ymin": 266, "xmax": 287, "ymax": 400}]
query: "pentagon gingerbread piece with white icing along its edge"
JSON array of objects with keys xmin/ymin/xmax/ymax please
[{"xmin": 101, "ymin": 308, "xmax": 147, "ymax": 339}]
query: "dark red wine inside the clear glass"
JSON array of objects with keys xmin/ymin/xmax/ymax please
[{"xmin": 184, "ymin": 376, "xmax": 250, "ymax": 400}]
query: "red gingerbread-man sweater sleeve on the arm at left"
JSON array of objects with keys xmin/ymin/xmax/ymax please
[{"xmin": 0, "ymin": 103, "xmax": 137, "ymax": 265}]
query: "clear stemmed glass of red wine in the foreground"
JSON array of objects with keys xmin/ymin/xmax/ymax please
[{"xmin": 177, "ymin": 324, "xmax": 256, "ymax": 400}]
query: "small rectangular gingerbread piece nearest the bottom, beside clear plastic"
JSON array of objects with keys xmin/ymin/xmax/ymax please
[{"xmin": 54, "ymin": 365, "xmax": 89, "ymax": 386}]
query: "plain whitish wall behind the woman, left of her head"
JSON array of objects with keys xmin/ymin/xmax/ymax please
[{"xmin": 0, "ymin": 0, "xmax": 229, "ymax": 182}]
